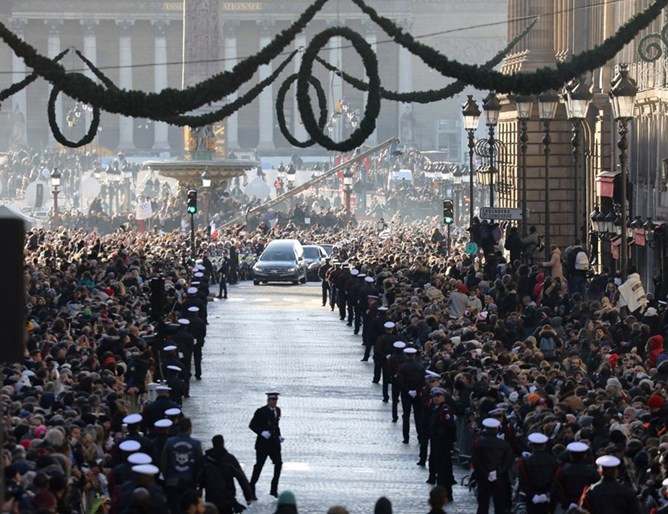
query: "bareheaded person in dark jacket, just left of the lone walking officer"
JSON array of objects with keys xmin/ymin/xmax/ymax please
[{"xmin": 201, "ymin": 434, "xmax": 253, "ymax": 514}]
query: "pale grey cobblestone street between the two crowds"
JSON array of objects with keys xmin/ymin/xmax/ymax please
[{"xmin": 184, "ymin": 283, "xmax": 475, "ymax": 514}]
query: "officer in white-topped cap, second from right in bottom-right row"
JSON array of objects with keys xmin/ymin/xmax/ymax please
[{"xmin": 551, "ymin": 441, "xmax": 598, "ymax": 511}]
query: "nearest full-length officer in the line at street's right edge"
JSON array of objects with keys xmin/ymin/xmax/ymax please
[{"xmin": 423, "ymin": 387, "xmax": 457, "ymax": 501}]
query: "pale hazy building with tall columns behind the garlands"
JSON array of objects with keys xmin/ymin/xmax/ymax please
[{"xmin": 0, "ymin": 0, "xmax": 506, "ymax": 156}]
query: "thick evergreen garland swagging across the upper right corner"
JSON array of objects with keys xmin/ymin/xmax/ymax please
[{"xmin": 352, "ymin": 0, "xmax": 668, "ymax": 94}]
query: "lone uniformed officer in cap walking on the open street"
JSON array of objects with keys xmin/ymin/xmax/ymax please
[{"xmin": 248, "ymin": 392, "xmax": 283, "ymax": 500}]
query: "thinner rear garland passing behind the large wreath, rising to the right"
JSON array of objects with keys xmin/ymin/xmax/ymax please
[{"xmin": 316, "ymin": 18, "xmax": 538, "ymax": 104}]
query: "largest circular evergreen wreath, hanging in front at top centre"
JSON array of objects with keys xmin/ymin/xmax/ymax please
[{"xmin": 297, "ymin": 27, "xmax": 380, "ymax": 152}]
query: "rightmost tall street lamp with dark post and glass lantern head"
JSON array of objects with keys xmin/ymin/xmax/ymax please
[{"xmin": 610, "ymin": 64, "xmax": 638, "ymax": 280}]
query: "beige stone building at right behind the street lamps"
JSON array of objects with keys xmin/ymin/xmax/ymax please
[{"xmin": 497, "ymin": 0, "xmax": 668, "ymax": 292}]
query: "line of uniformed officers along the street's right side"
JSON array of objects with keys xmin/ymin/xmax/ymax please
[{"xmin": 319, "ymin": 259, "xmax": 640, "ymax": 514}]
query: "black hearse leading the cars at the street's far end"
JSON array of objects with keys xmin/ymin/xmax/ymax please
[{"xmin": 253, "ymin": 239, "xmax": 306, "ymax": 285}]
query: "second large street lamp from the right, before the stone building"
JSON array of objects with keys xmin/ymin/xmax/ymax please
[{"xmin": 563, "ymin": 80, "xmax": 593, "ymax": 241}]
